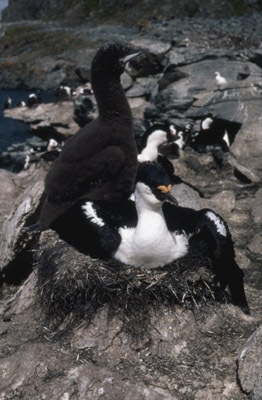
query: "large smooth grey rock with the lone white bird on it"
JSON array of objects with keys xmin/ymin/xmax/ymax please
[{"xmin": 154, "ymin": 58, "xmax": 261, "ymax": 119}]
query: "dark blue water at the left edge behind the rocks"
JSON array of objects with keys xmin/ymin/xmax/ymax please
[{"xmin": 0, "ymin": 90, "xmax": 54, "ymax": 153}]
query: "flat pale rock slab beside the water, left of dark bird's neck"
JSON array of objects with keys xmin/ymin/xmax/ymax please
[{"xmin": 5, "ymin": 101, "xmax": 79, "ymax": 140}]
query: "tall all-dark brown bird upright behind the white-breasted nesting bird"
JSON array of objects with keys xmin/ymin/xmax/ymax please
[{"xmin": 36, "ymin": 44, "xmax": 141, "ymax": 229}]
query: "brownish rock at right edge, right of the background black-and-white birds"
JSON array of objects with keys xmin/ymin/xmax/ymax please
[{"xmin": 230, "ymin": 121, "xmax": 262, "ymax": 182}]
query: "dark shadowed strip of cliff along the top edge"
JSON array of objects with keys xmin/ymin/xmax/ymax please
[{"xmin": 2, "ymin": 0, "xmax": 262, "ymax": 24}]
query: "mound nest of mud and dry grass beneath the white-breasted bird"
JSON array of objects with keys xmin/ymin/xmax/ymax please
[{"xmin": 37, "ymin": 231, "xmax": 230, "ymax": 337}]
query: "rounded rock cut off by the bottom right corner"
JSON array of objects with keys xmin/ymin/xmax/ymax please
[{"xmin": 238, "ymin": 325, "xmax": 262, "ymax": 400}]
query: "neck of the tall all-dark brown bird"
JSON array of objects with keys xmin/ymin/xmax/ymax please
[{"xmin": 92, "ymin": 74, "xmax": 132, "ymax": 123}]
